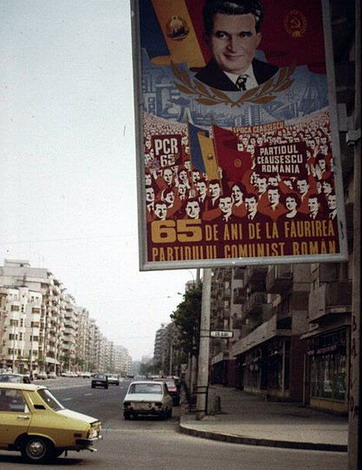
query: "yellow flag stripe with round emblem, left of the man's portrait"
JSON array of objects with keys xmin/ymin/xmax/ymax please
[{"xmin": 152, "ymin": 0, "xmax": 205, "ymax": 68}]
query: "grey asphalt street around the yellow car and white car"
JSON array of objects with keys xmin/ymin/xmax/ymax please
[{"xmin": 0, "ymin": 378, "xmax": 347, "ymax": 470}]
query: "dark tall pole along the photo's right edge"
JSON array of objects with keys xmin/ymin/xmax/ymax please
[{"xmin": 347, "ymin": 0, "xmax": 362, "ymax": 470}]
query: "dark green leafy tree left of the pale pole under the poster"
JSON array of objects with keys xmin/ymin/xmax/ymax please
[{"xmin": 170, "ymin": 283, "xmax": 202, "ymax": 356}]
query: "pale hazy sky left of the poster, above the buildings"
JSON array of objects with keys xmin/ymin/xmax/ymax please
[{"xmin": 0, "ymin": 0, "xmax": 196, "ymax": 360}]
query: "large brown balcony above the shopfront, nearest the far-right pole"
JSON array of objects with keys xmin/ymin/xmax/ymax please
[{"xmin": 309, "ymin": 281, "xmax": 352, "ymax": 323}]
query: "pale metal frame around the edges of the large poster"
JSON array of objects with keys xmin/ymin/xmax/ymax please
[{"xmin": 130, "ymin": 0, "xmax": 348, "ymax": 271}]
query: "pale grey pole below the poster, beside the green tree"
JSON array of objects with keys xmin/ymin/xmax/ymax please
[{"xmin": 196, "ymin": 268, "xmax": 211, "ymax": 420}]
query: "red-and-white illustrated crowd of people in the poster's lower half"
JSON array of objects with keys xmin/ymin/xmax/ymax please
[{"xmin": 144, "ymin": 112, "xmax": 337, "ymax": 227}]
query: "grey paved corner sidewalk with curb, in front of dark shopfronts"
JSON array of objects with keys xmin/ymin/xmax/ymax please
[{"xmin": 179, "ymin": 385, "xmax": 348, "ymax": 452}]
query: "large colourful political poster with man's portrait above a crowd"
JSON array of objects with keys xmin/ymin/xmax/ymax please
[{"xmin": 134, "ymin": 0, "xmax": 347, "ymax": 269}]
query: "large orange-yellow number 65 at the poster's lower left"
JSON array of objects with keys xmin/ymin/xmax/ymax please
[{"xmin": 151, "ymin": 219, "xmax": 202, "ymax": 243}]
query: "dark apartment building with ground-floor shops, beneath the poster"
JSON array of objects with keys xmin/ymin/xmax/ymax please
[{"xmin": 210, "ymin": 263, "xmax": 352, "ymax": 412}]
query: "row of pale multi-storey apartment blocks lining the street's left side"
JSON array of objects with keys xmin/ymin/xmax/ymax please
[{"xmin": 0, "ymin": 260, "xmax": 128, "ymax": 374}]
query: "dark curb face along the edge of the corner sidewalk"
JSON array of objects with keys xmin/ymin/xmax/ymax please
[{"xmin": 179, "ymin": 423, "xmax": 348, "ymax": 452}]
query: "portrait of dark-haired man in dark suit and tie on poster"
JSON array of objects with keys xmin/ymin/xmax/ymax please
[{"xmin": 195, "ymin": 0, "xmax": 279, "ymax": 91}]
